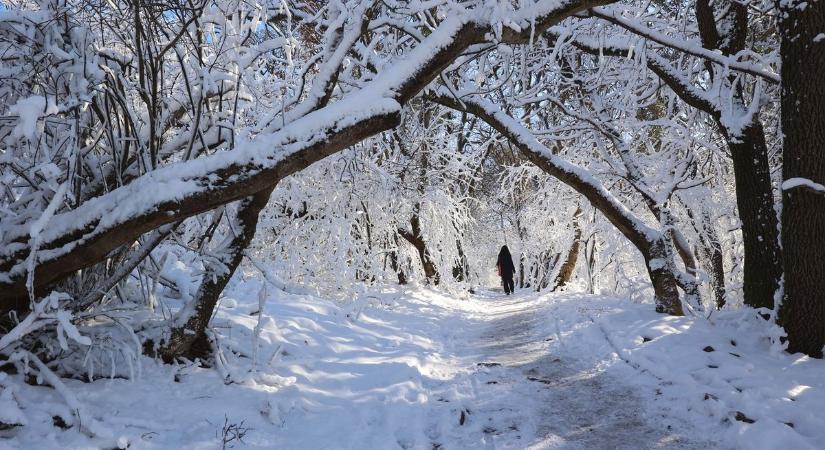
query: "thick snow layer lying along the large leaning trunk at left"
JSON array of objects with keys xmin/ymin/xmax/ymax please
[{"xmin": 0, "ymin": 4, "xmax": 474, "ymax": 282}]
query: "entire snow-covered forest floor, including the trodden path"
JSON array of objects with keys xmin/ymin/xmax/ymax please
[{"xmin": 0, "ymin": 278, "xmax": 825, "ymax": 450}]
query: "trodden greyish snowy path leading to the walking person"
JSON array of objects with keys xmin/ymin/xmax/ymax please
[{"xmin": 434, "ymin": 292, "xmax": 711, "ymax": 449}]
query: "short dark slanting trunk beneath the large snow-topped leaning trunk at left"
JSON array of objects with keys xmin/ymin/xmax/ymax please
[{"xmin": 158, "ymin": 186, "xmax": 274, "ymax": 362}]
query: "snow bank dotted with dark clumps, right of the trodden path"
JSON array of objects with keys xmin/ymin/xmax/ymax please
[{"xmin": 548, "ymin": 298, "xmax": 825, "ymax": 449}]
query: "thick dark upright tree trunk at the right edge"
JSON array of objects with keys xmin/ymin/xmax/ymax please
[{"xmin": 777, "ymin": 1, "xmax": 825, "ymax": 358}]
